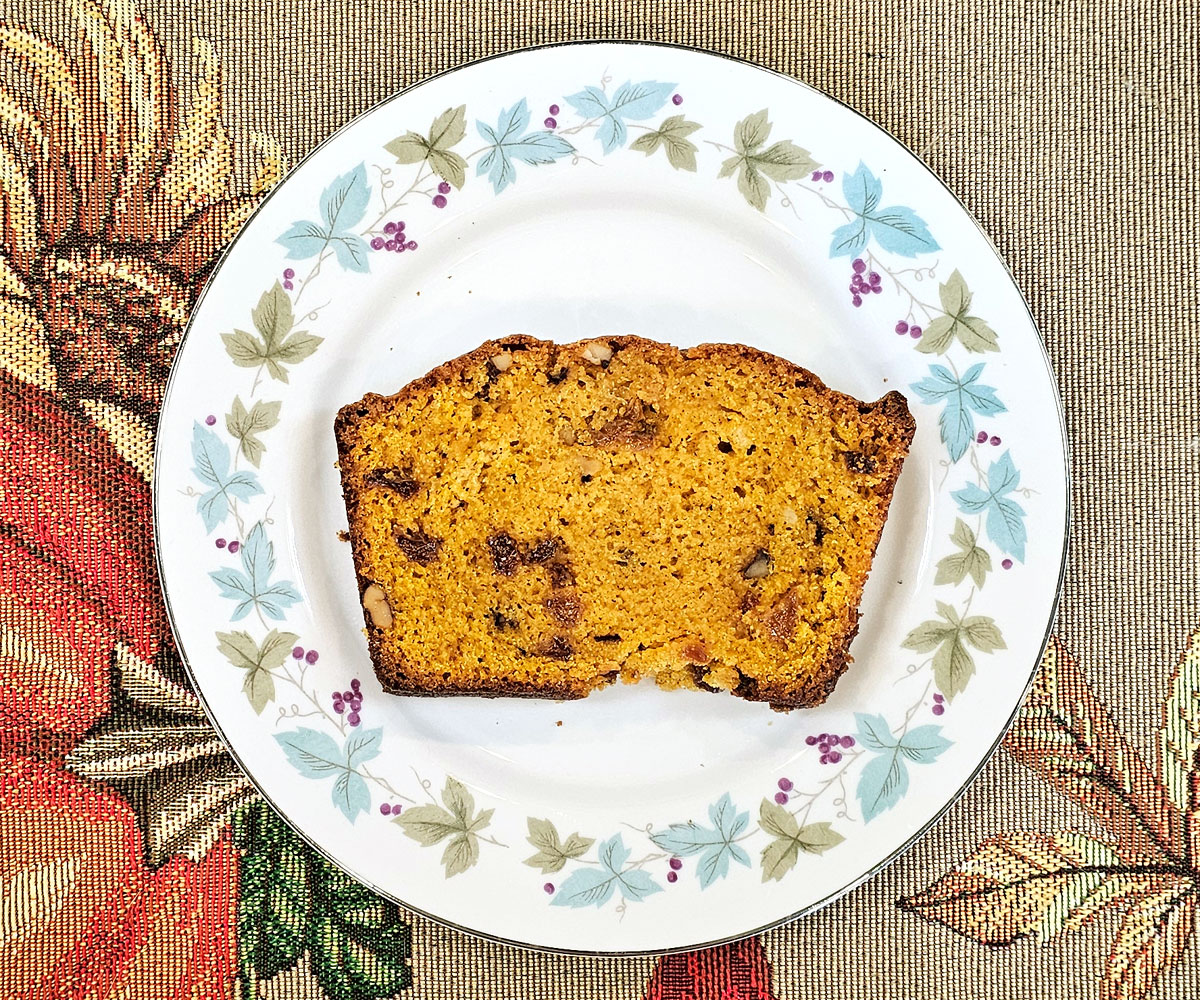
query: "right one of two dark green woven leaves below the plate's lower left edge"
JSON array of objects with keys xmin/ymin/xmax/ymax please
[{"xmin": 307, "ymin": 845, "xmax": 413, "ymax": 1000}]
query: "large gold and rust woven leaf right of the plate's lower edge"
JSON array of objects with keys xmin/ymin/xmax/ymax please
[{"xmin": 899, "ymin": 630, "xmax": 1200, "ymax": 1000}]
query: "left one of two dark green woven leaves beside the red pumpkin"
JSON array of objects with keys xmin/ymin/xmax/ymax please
[{"xmin": 233, "ymin": 802, "xmax": 312, "ymax": 982}]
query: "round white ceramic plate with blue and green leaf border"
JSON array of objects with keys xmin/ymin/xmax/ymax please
[{"xmin": 155, "ymin": 44, "xmax": 1067, "ymax": 952}]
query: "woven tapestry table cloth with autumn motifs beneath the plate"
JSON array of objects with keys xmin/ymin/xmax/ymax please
[{"xmin": 0, "ymin": 0, "xmax": 1200, "ymax": 1000}]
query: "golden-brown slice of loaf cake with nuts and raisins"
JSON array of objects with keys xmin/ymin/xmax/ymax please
[{"xmin": 335, "ymin": 336, "xmax": 916, "ymax": 708}]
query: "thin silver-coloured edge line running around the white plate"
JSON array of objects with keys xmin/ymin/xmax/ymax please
[{"xmin": 151, "ymin": 38, "xmax": 1073, "ymax": 958}]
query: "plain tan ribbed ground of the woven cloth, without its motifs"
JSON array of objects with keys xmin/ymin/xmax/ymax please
[{"xmin": 0, "ymin": 0, "xmax": 1200, "ymax": 1000}]
